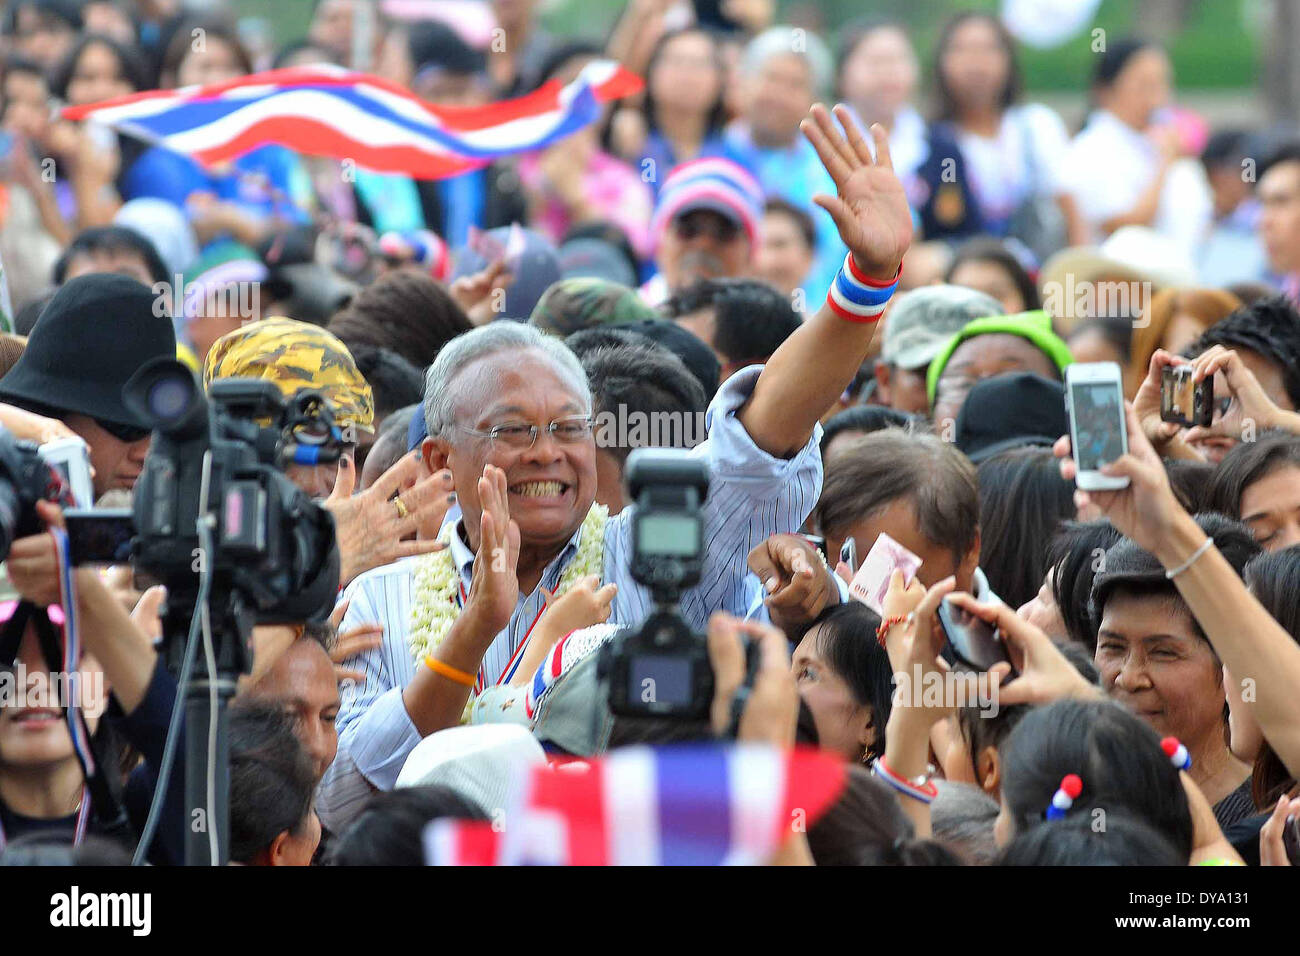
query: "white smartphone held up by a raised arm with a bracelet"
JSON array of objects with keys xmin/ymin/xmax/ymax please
[{"xmin": 1065, "ymin": 362, "xmax": 1128, "ymax": 492}]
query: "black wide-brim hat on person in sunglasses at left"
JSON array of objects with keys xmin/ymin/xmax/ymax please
[{"xmin": 0, "ymin": 272, "xmax": 176, "ymax": 428}]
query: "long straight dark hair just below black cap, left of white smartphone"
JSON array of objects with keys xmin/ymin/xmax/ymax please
[{"xmin": 979, "ymin": 447, "xmax": 1075, "ymax": 607}]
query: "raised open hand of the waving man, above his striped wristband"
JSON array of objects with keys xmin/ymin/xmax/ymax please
[{"xmin": 800, "ymin": 103, "xmax": 913, "ymax": 281}]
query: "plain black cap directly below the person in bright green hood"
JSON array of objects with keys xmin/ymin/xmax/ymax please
[{"xmin": 954, "ymin": 372, "xmax": 1070, "ymax": 464}]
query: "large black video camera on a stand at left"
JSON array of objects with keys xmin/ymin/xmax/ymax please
[{"xmin": 122, "ymin": 358, "xmax": 342, "ymax": 672}]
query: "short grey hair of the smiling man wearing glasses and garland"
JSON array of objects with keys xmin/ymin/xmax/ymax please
[{"xmin": 424, "ymin": 320, "xmax": 592, "ymax": 438}]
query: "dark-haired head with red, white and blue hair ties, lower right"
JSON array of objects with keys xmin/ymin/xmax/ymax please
[{"xmin": 993, "ymin": 700, "xmax": 1195, "ymax": 865}]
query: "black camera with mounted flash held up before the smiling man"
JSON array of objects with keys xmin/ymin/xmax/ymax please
[{"xmin": 599, "ymin": 449, "xmax": 714, "ymax": 719}]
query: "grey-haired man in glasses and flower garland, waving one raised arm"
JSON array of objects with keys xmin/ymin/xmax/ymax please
[{"xmin": 321, "ymin": 105, "xmax": 911, "ymax": 813}]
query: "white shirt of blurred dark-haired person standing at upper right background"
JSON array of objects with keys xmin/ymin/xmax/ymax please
[{"xmin": 1065, "ymin": 109, "xmax": 1213, "ymax": 256}]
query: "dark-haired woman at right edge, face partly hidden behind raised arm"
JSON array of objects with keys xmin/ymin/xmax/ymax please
[{"xmin": 1205, "ymin": 432, "xmax": 1300, "ymax": 551}]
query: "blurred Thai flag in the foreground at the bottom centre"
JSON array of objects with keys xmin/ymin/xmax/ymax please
[{"xmin": 425, "ymin": 744, "xmax": 846, "ymax": 866}]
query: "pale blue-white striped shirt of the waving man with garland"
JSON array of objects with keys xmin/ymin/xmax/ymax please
[{"xmin": 321, "ymin": 365, "xmax": 822, "ymax": 829}]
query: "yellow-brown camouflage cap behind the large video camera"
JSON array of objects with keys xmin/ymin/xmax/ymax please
[{"xmin": 203, "ymin": 316, "xmax": 374, "ymax": 432}]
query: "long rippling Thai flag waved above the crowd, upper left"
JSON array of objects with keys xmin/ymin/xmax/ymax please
[{"xmin": 64, "ymin": 60, "xmax": 641, "ymax": 179}]
